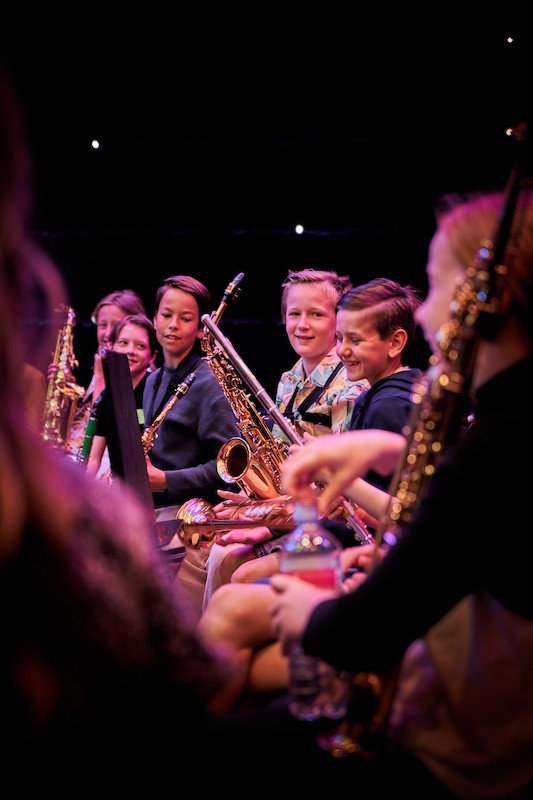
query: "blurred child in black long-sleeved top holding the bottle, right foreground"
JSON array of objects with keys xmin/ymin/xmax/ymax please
[{"xmin": 272, "ymin": 187, "xmax": 533, "ymax": 800}]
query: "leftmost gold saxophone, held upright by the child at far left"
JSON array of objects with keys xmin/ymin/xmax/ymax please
[{"xmin": 41, "ymin": 305, "xmax": 85, "ymax": 449}]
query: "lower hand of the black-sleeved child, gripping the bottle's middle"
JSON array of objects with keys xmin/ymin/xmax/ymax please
[{"xmin": 270, "ymin": 573, "xmax": 337, "ymax": 655}]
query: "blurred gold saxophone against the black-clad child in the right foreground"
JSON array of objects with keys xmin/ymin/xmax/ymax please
[{"xmin": 318, "ymin": 134, "xmax": 521, "ymax": 760}]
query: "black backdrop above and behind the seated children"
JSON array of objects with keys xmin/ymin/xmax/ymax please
[{"xmin": 3, "ymin": 17, "xmax": 532, "ymax": 395}]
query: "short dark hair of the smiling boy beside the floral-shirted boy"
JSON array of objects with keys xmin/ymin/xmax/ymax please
[{"xmin": 337, "ymin": 278, "xmax": 422, "ymax": 352}]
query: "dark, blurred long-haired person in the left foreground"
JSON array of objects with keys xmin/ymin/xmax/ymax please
[{"xmin": 0, "ymin": 61, "xmax": 231, "ymax": 796}]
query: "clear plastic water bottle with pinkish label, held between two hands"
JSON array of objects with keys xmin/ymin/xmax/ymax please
[{"xmin": 280, "ymin": 496, "xmax": 350, "ymax": 720}]
